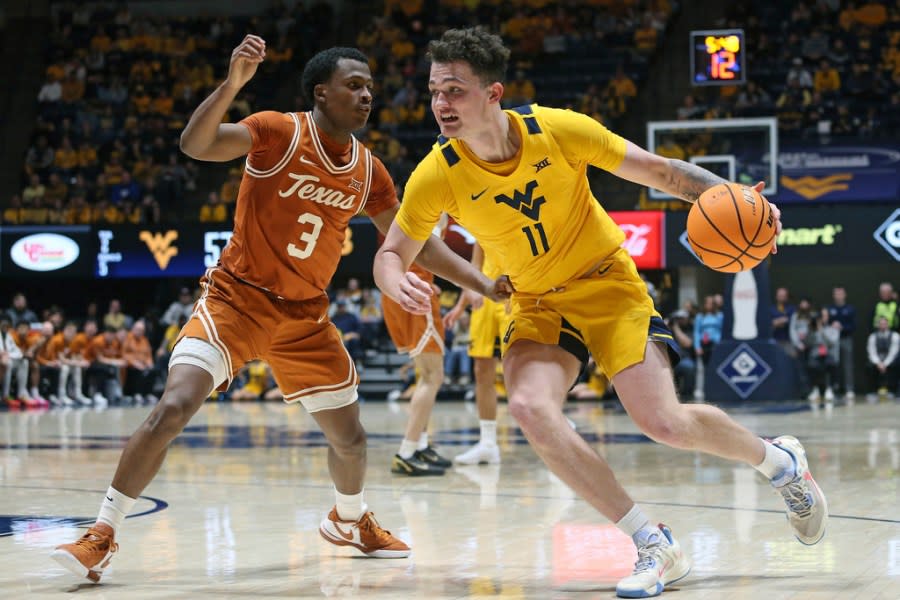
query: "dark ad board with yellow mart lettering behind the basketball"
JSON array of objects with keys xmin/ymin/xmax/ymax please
[{"xmin": 666, "ymin": 206, "xmax": 900, "ymax": 266}]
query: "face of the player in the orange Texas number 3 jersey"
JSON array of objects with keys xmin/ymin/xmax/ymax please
[{"xmin": 316, "ymin": 58, "xmax": 373, "ymax": 133}]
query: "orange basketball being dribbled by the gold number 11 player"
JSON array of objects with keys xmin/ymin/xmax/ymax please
[{"xmin": 687, "ymin": 183, "xmax": 775, "ymax": 273}]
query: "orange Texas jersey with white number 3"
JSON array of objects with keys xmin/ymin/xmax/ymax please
[{"xmin": 220, "ymin": 111, "xmax": 397, "ymax": 300}]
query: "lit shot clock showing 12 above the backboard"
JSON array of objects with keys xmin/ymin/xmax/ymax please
[{"xmin": 691, "ymin": 29, "xmax": 747, "ymax": 85}]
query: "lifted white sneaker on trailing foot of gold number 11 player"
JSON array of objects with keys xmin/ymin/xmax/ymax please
[{"xmin": 772, "ymin": 435, "xmax": 828, "ymax": 546}]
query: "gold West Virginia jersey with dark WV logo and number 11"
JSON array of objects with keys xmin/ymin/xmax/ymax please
[{"xmin": 396, "ymin": 104, "xmax": 625, "ymax": 294}]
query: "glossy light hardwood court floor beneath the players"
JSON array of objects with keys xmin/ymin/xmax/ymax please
[{"xmin": 0, "ymin": 396, "xmax": 900, "ymax": 600}]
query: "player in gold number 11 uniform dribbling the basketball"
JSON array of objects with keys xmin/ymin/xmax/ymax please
[{"xmin": 375, "ymin": 29, "xmax": 827, "ymax": 597}]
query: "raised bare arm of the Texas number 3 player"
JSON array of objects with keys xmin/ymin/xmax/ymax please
[{"xmin": 181, "ymin": 35, "xmax": 266, "ymax": 162}]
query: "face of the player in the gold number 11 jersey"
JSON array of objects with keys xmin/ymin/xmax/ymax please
[{"xmin": 428, "ymin": 62, "xmax": 503, "ymax": 138}]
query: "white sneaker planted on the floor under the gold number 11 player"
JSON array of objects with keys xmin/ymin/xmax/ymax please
[{"xmin": 616, "ymin": 523, "xmax": 691, "ymax": 598}]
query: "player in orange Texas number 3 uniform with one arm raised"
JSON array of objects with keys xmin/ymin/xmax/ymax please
[{"xmin": 53, "ymin": 35, "xmax": 501, "ymax": 582}]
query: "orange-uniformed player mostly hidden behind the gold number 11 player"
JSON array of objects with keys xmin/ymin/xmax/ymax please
[{"xmin": 381, "ymin": 218, "xmax": 451, "ymax": 477}]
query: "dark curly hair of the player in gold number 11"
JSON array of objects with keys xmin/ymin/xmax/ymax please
[{"xmin": 427, "ymin": 27, "xmax": 509, "ymax": 85}]
